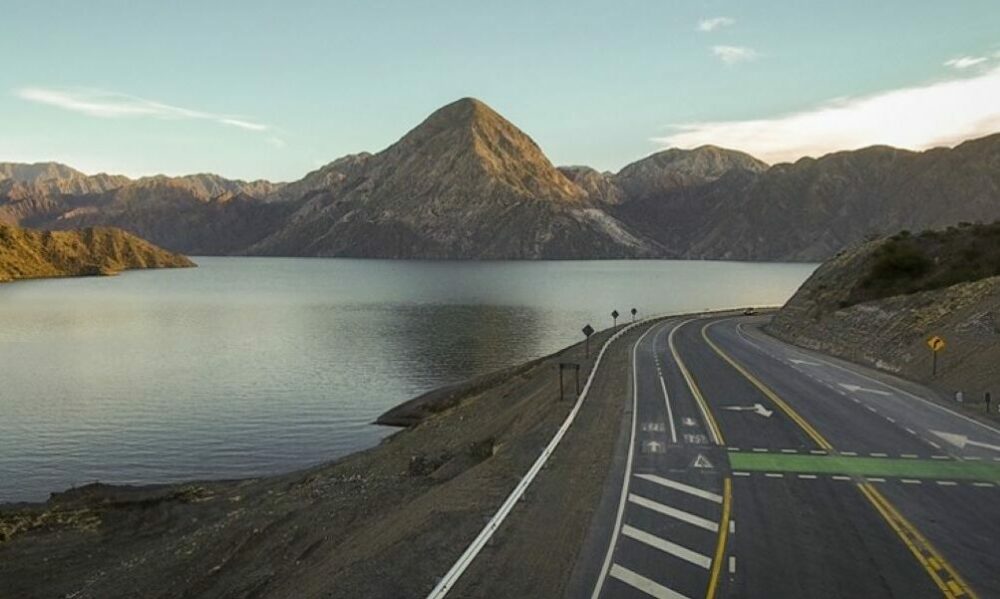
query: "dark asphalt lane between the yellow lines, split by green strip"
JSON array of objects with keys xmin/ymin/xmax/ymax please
[{"xmin": 677, "ymin": 322, "xmax": 941, "ymax": 597}]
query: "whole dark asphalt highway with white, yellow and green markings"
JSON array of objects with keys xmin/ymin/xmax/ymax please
[{"xmin": 569, "ymin": 317, "xmax": 1000, "ymax": 599}]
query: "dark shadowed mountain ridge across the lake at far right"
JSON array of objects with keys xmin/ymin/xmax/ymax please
[{"xmin": 632, "ymin": 135, "xmax": 1000, "ymax": 261}]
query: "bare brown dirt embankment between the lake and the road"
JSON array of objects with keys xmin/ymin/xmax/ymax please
[{"xmin": 0, "ymin": 322, "xmax": 638, "ymax": 599}]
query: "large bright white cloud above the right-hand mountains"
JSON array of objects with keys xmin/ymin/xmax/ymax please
[{"xmin": 653, "ymin": 67, "xmax": 1000, "ymax": 163}]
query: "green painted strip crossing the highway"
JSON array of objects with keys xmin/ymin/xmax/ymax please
[{"xmin": 728, "ymin": 452, "xmax": 1000, "ymax": 482}]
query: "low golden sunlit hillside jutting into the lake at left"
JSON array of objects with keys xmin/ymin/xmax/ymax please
[{"xmin": 0, "ymin": 224, "xmax": 194, "ymax": 282}]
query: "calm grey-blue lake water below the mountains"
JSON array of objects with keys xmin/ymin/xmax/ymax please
[{"xmin": 0, "ymin": 258, "xmax": 814, "ymax": 502}]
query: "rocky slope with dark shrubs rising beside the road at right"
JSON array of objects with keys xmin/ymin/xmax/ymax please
[{"xmin": 767, "ymin": 222, "xmax": 1000, "ymax": 401}]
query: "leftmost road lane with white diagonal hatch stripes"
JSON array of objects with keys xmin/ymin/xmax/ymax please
[{"xmin": 591, "ymin": 322, "xmax": 728, "ymax": 599}]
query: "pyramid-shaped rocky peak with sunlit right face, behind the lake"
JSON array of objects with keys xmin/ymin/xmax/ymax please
[{"xmin": 248, "ymin": 98, "xmax": 658, "ymax": 259}]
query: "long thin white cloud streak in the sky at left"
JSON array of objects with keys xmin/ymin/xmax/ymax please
[{"xmin": 14, "ymin": 87, "xmax": 271, "ymax": 131}]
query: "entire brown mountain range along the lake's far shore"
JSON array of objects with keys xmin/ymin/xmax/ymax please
[{"xmin": 0, "ymin": 98, "xmax": 1000, "ymax": 260}]
